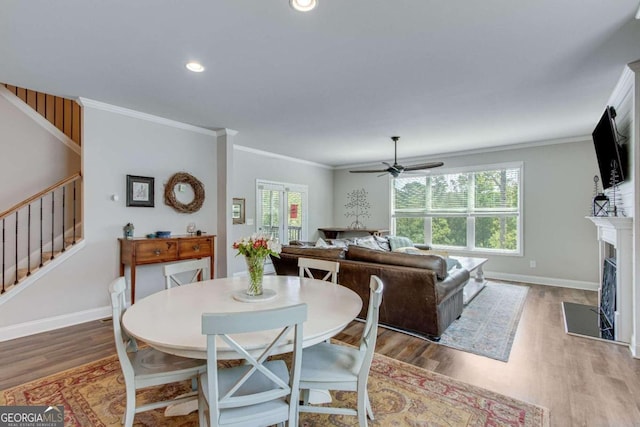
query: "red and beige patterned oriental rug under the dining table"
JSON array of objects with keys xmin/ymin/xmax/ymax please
[{"xmin": 0, "ymin": 355, "xmax": 549, "ymax": 427}]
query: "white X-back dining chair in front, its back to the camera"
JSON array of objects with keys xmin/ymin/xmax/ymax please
[{"xmin": 198, "ymin": 304, "xmax": 307, "ymax": 427}]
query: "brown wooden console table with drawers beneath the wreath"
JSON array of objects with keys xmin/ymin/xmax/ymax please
[{"xmin": 118, "ymin": 234, "xmax": 216, "ymax": 304}]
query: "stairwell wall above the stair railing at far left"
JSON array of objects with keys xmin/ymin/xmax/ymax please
[{"xmin": 0, "ymin": 94, "xmax": 80, "ymax": 212}]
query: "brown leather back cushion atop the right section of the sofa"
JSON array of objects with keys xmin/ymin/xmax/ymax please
[{"xmin": 345, "ymin": 246, "xmax": 447, "ymax": 280}]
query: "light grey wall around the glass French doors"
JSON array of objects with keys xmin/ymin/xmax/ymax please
[{"xmin": 231, "ymin": 145, "xmax": 334, "ymax": 273}]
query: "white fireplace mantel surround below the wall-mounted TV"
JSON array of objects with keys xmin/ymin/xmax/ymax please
[{"xmin": 587, "ymin": 216, "xmax": 633, "ymax": 343}]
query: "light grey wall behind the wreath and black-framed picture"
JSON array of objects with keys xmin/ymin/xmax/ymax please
[{"xmin": 0, "ymin": 105, "xmax": 217, "ymax": 326}]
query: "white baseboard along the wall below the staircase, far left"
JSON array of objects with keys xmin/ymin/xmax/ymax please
[{"xmin": 0, "ymin": 306, "xmax": 111, "ymax": 342}]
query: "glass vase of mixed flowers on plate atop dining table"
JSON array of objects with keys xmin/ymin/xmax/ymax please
[{"xmin": 233, "ymin": 234, "xmax": 282, "ymax": 302}]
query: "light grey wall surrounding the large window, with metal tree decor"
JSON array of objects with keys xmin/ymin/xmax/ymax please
[{"xmin": 334, "ymin": 140, "xmax": 599, "ymax": 289}]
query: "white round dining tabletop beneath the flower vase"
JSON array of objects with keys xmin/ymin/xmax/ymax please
[{"xmin": 122, "ymin": 276, "xmax": 362, "ymax": 359}]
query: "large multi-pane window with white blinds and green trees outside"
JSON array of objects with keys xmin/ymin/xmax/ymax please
[{"xmin": 392, "ymin": 163, "xmax": 522, "ymax": 254}]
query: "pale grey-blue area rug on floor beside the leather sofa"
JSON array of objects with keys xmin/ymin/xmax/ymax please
[{"xmin": 439, "ymin": 282, "xmax": 529, "ymax": 362}]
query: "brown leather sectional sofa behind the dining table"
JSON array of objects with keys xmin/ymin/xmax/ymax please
[{"xmin": 271, "ymin": 246, "xmax": 469, "ymax": 340}]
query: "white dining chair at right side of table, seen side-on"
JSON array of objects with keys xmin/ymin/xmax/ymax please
[{"xmin": 299, "ymin": 276, "xmax": 384, "ymax": 427}]
